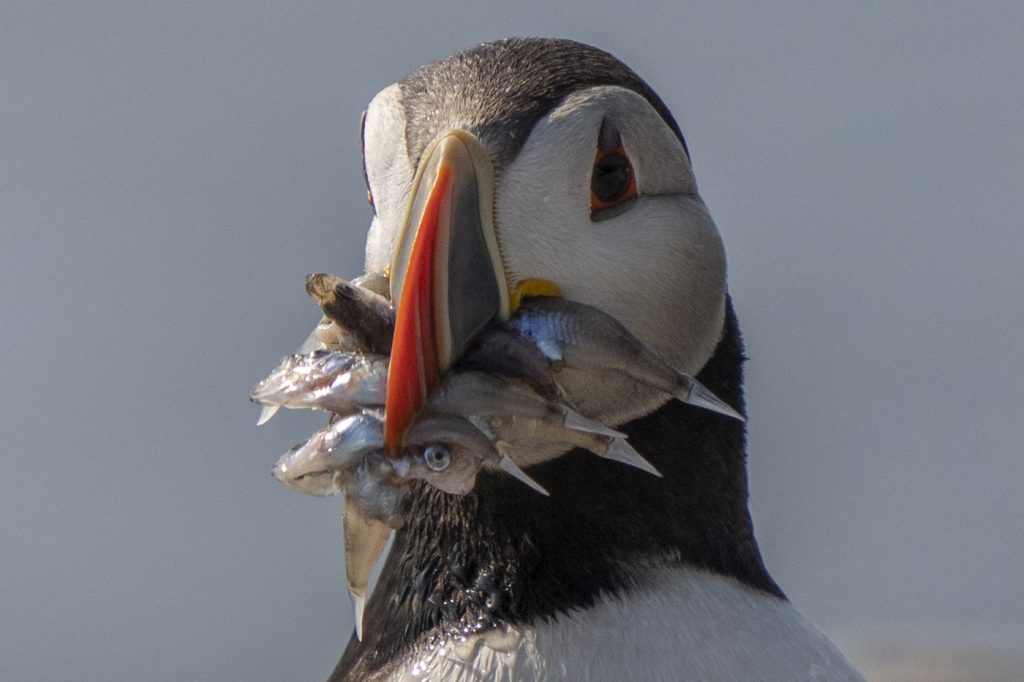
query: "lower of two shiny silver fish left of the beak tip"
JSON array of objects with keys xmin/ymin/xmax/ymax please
[{"xmin": 273, "ymin": 411, "xmax": 384, "ymax": 497}]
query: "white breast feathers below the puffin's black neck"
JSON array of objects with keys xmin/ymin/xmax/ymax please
[{"xmin": 389, "ymin": 568, "xmax": 863, "ymax": 682}]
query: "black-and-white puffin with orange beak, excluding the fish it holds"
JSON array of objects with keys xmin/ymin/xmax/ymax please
[{"xmin": 330, "ymin": 38, "xmax": 862, "ymax": 682}]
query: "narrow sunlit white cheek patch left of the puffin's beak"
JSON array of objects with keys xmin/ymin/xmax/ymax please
[{"xmin": 364, "ymin": 84, "xmax": 414, "ymax": 272}]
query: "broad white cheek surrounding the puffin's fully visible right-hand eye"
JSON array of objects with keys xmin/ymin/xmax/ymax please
[{"xmin": 496, "ymin": 87, "xmax": 726, "ymax": 374}]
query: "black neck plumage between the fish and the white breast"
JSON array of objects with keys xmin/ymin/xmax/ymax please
[{"xmin": 331, "ymin": 303, "xmax": 782, "ymax": 680}]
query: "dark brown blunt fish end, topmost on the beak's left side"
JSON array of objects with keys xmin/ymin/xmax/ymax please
[{"xmin": 306, "ymin": 272, "xmax": 394, "ymax": 355}]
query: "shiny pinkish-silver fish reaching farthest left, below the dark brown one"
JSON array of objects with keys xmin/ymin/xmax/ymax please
[{"xmin": 249, "ymin": 349, "xmax": 388, "ymax": 414}]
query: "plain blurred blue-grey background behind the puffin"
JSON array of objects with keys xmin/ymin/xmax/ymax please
[{"xmin": 0, "ymin": 0, "xmax": 1024, "ymax": 680}]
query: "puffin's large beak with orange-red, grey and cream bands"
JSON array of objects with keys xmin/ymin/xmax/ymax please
[{"xmin": 384, "ymin": 130, "xmax": 509, "ymax": 456}]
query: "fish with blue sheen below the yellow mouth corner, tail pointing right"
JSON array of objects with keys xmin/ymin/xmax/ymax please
[{"xmin": 505, "ymin": 297, "xmax": 745, "ymax": 421}]
